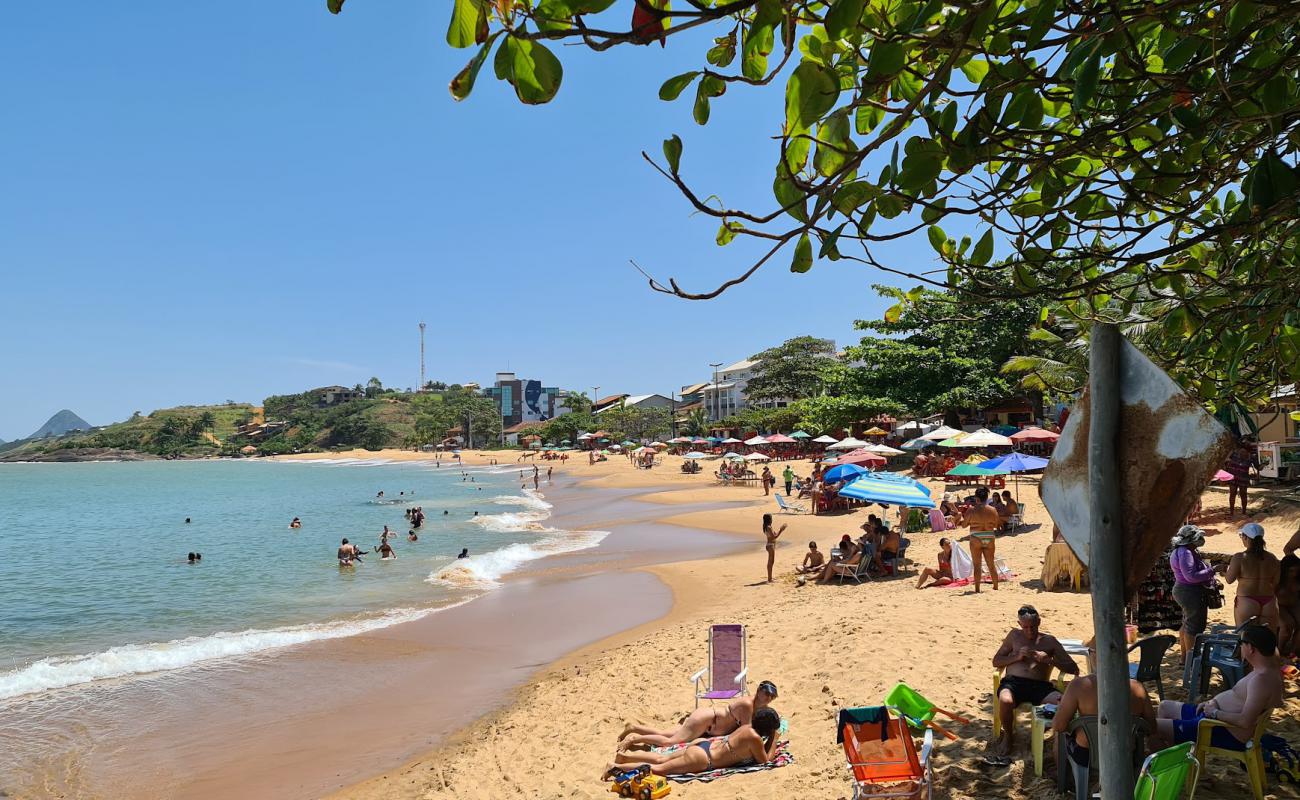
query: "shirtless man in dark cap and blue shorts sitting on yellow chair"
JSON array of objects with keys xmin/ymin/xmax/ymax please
[{"xmin": 1156, "ymin": 624, "xmax": 1282, "ymax": 751}]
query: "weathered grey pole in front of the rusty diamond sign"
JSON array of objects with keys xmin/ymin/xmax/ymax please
[{"xmin": 1088, "ymin": 323, "xmax": 1134, "ymax": 797}]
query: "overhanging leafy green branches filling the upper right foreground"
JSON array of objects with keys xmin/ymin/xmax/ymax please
[{"xmin": 328, "ymin": 0, "xmax": 1300, "ymax": 405}]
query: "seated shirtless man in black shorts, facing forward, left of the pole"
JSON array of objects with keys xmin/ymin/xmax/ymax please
[{"xmin": 976, "ymin": 606, "xmax": 1079, "ymax": 756}]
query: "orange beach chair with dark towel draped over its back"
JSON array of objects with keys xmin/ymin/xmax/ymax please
[{"xmin": 839, "ymin": 705, "xmax": 935, "ymax": 800}]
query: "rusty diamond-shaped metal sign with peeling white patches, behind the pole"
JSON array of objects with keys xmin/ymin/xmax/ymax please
[{"xmin": 1041, "ymin": 340, "xmax": 1232, "ymax": 598}]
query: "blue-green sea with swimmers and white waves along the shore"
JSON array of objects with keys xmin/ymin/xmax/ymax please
[{"xmin": 0, "ymin": 459, "xmax": 603, "ymax": 701}]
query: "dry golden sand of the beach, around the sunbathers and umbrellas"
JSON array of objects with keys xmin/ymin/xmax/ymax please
[{"xmin": 274, "ymin": 451, "xmax": 1300, "ymax": 800}]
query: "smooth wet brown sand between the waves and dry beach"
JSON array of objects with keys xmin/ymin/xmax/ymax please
[{"xmin": 0, "ymin": 476, "xmax": 745, "ymax": 800}]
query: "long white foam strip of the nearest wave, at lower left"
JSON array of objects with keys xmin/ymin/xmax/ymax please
[{"xmin": 0, "ymin": 601, "xmax": 468, "ymax": 700}]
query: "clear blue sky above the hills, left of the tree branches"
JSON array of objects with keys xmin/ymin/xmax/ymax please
[{"xmin": 0, "ymin": 0, "xmax": 935, "ymax": 440}]
